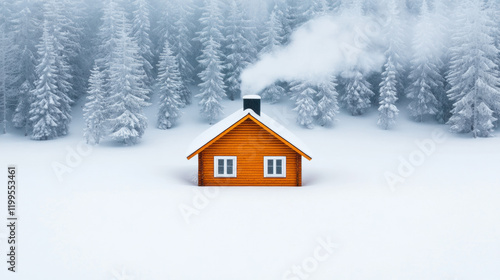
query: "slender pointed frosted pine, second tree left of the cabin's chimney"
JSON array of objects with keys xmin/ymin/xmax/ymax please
[{"xmin": 156, "ymin": 40, "xmax": 183, "ymax": 129}]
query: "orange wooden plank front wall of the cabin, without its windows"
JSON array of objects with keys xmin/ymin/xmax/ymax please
[{"xmin": 198, "ymin": 119, "xmax": 302, "ymax": 186}]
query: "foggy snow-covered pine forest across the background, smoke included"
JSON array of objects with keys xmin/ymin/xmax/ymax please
[{"xmin": 0, "ymin": 0, "xmax": 500, "ymax": 144}]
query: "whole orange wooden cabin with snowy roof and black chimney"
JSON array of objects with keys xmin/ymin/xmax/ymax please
[{"xmin": 187, "ymin": 95, "xmax": 311, "ymax": 186}]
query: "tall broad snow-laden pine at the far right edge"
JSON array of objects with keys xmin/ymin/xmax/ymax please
[{"xmin": 447, "ymin": 0, "xmax": 500, "ymax": 137}]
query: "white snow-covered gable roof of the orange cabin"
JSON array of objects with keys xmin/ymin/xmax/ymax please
[{"xmin": 186, "ymin": 109, "xmax": 311, "ymax": 159}]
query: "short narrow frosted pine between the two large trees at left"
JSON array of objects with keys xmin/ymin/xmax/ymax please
[{"xmin": 83, "ymin": 66, "xmax": 106, "ymax": 145}]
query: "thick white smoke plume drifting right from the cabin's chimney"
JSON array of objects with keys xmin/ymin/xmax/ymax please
[{"xmin": 241, "ymin": 14, "xmax": 384, "ymax": 95}]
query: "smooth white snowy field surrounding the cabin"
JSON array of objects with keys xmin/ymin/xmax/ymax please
[{"xmin": 0, "ymin": 95, "xmax": 500, "ymax": 280}]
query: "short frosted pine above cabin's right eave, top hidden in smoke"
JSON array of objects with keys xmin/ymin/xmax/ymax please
[{"xmin": 291, "ymin": 81, "xmax": 318, "ymax": 128}]
